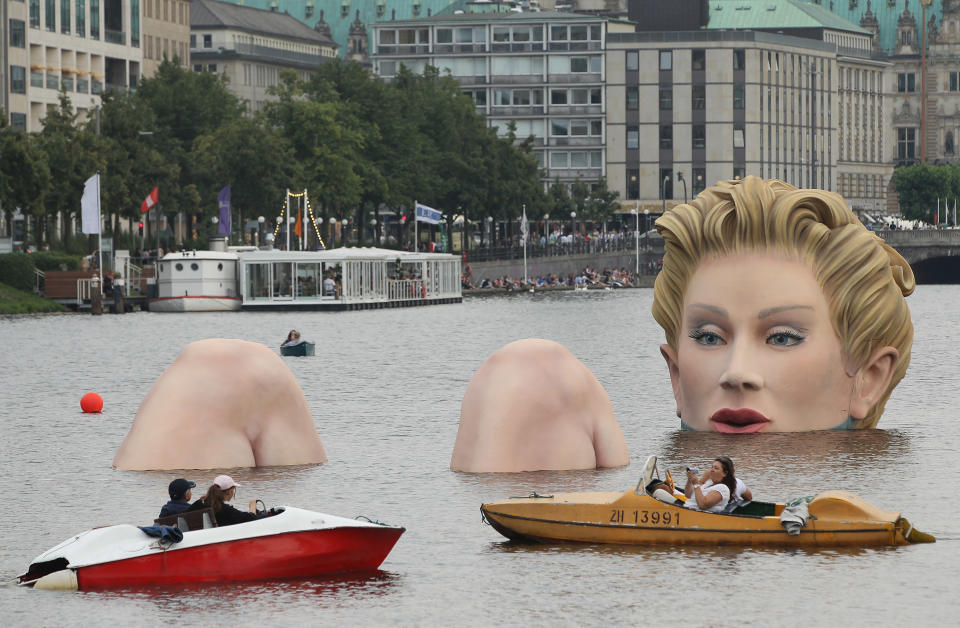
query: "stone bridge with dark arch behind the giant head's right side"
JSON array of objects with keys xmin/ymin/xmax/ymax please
[{"xmin": 875, "ymin": 229, "xmax": 960, "ymax": 284}]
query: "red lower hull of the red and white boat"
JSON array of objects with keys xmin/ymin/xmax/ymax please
[{"xmin": 77, "ymin": 527, "xmax": 403, "ymax": 590}]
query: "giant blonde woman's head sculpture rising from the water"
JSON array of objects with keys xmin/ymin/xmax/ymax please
[{"xmin": 653, "ymin": 177, "xmax": 914, "ymax": 432}]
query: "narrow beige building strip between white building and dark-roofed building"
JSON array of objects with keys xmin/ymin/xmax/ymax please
[{"xmin": 141, "ymin": 0, "xmax": 190, "ymax": 78}]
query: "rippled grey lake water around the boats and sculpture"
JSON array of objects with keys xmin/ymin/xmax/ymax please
[{"xmin": 0, "ymin": 286, "xmax": 960, "ymax": 626}]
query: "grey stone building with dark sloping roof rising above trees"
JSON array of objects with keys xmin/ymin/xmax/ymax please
[{"xmin": 190, "ymin": 0, "xmax": 337, "ymax": 112}]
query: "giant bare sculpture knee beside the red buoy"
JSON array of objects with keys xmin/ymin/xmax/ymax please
[{"xmin": 113, "ymin": 338, "xmax": 327, "ymax": 470}]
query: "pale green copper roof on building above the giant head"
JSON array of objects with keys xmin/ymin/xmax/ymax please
[{"xmin": 707, "ymin": 0, "xmax": 869, "ymax": 34}]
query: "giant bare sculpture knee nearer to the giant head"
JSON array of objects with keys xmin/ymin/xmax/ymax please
[{"xmin": 450, "ymin": 339, "xmax": 630, "ymax": 472}]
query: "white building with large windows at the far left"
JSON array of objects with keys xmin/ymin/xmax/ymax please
[{"xmin": 0, "ymin": 0, "xmax": 142, "ymax": 132}]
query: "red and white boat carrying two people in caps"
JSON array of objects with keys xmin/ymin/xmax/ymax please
[{"xmin": 17, "ymin": 508, "xmax": 404, "ymax": 590}]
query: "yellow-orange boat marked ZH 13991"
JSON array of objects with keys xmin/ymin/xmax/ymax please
[{"xmin": 480, "ymin": 456, "xmax": 935, "ymax": 547}]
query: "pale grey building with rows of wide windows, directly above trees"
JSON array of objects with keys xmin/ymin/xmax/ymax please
[{"xmin": 372, "ymin": 11, "xmax": 632, "ymax": 185}]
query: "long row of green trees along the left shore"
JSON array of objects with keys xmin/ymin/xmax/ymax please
[{"xmin": 0, "ymin": 60, "xmax": 616, "ymax": 250}]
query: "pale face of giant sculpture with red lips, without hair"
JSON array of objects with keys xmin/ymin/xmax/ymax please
[{"xmin": 662, "ymin": 253, "xmax": 855, "ymax": 433}]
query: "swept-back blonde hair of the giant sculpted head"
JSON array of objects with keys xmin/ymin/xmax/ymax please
[{"xmin": 653, "ymin": 176, "xmax": 914, "ymax": 428}]
